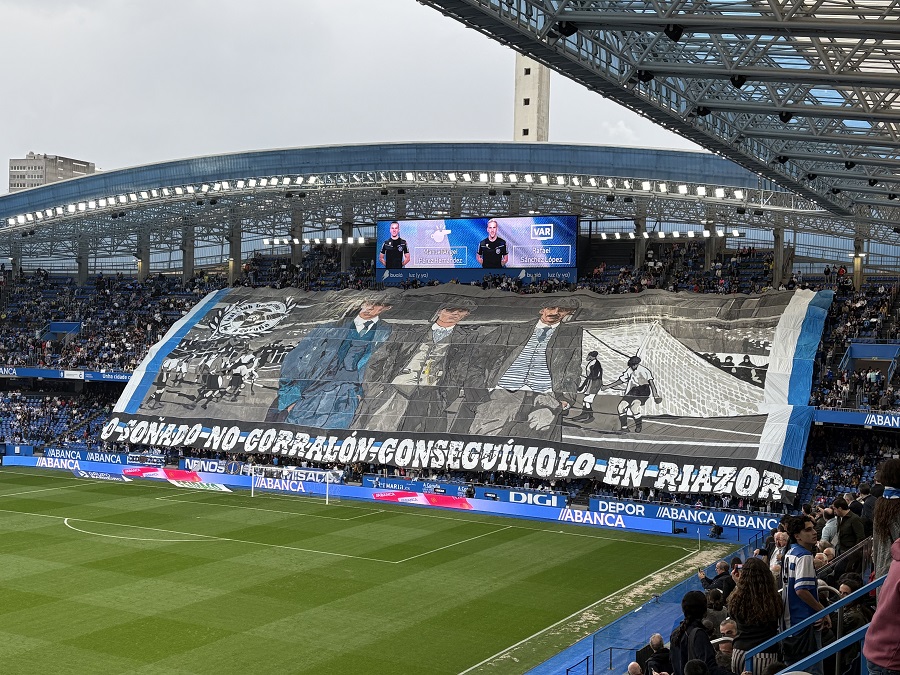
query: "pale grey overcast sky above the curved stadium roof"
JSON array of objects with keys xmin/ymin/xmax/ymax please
[{"xmin": 0, "ymin": 0, "xmax": 699, "ymax": 193}]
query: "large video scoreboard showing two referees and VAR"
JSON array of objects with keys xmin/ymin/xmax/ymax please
[{"xmin": 376, "ymin": 215, "xmax": 578, "ymax": 280}]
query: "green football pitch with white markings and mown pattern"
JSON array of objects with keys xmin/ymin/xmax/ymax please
[{"xmin": 0, "ymin": 467, "xmax": 697, "ymax": 675}]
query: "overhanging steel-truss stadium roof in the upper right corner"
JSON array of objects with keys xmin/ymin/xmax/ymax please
[{"xmin": 422, "ymin": 0, "xmax": 900, "ymax": 224}]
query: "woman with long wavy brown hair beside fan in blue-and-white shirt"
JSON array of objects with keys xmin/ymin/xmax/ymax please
[{"xmin": 728, "ymin": 558, "xmax": 784, "ymax": 675}]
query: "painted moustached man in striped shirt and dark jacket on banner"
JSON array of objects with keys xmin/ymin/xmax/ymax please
[{"xmin": 450, "ymin": 300, "xmax": 582, "ymax": 441}]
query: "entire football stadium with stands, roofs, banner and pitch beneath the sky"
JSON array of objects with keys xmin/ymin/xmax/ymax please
[{"xmin": 0, "ymin": 0, "xmax": 900, "ymax": 675}]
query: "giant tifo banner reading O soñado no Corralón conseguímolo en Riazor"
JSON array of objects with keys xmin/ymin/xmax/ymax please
[{"xmin": 103, "ymin": 284, "xmax": 832, "ymax": 501}]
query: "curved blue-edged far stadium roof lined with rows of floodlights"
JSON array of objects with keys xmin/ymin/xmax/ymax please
[{"xmin": 0, "ymin": 143, "xmax": 890, "ymax": 271}]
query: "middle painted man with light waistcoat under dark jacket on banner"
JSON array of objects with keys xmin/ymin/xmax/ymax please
[{"xmin": 352, "ymin": 298, "xmax": 475, "ymax": 433}]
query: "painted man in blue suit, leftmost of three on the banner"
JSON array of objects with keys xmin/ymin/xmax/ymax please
[{"xmin": 269, "ymin": 300, "xmax": 391, "ymax": 429}]
